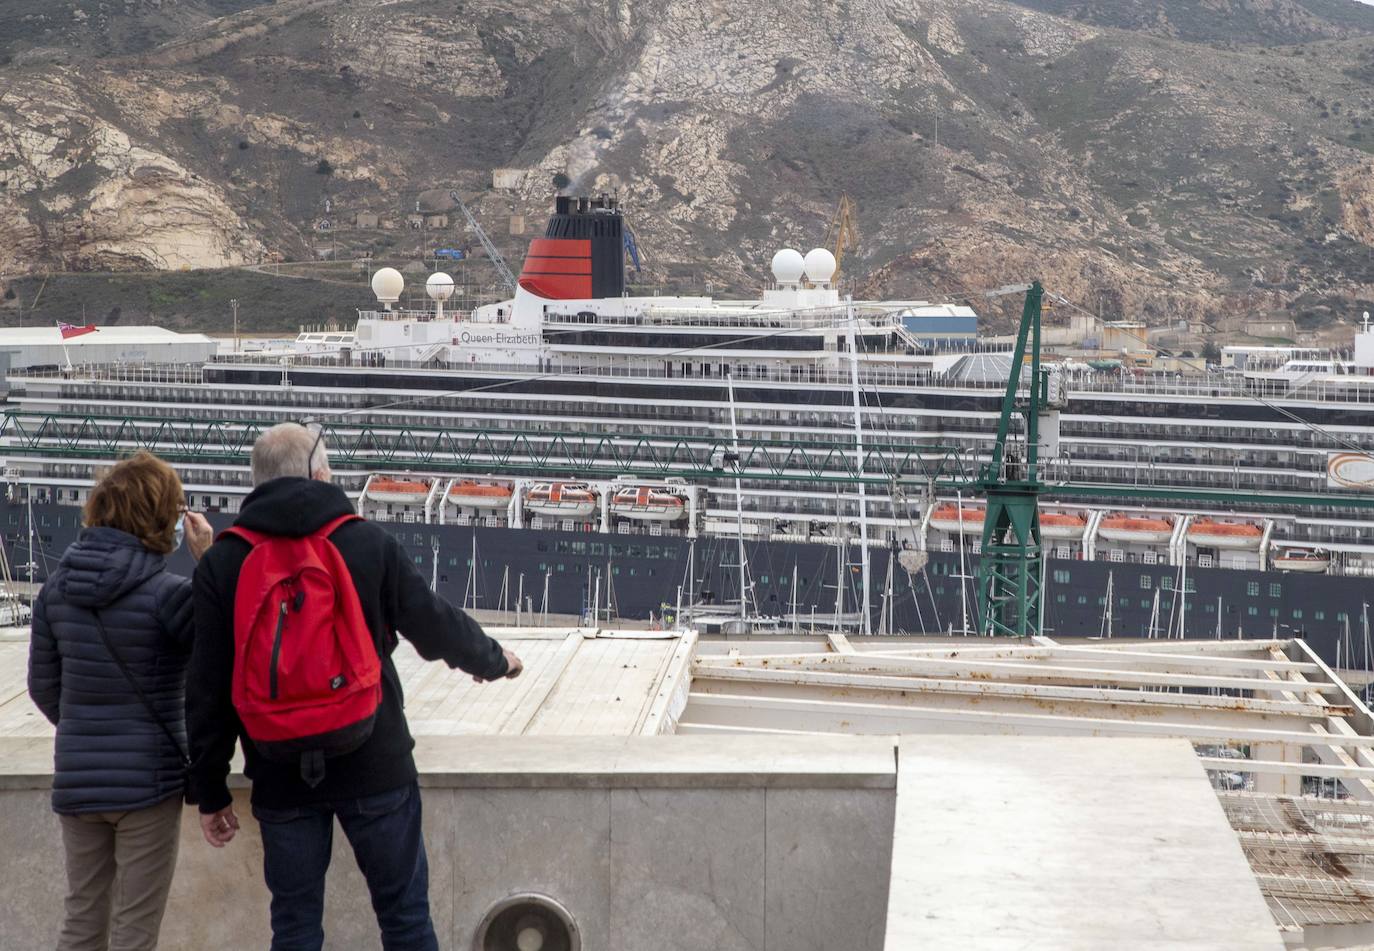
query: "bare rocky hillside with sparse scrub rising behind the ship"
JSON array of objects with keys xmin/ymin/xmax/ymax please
[{"xmin": 0, "ymin": 0, "xmax": 1374, "ymax": 331}]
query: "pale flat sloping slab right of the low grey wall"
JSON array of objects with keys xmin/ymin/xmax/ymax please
[{"xmin": 883, "ymin": 737, "xmax": 1283, "ymax": 951}]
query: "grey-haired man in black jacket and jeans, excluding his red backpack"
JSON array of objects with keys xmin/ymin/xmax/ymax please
[{"xmin": 187, "ymin": 423, "xmax": 521, "ymax": 951}]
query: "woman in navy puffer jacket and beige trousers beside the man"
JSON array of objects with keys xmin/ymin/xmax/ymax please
[{"xmin": 29, "ymin": 452, "xmax": 212, "ymax": 951}]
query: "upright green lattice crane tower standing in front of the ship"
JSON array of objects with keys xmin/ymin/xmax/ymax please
[{"xmin": 974, "ymin": 280, "xmax": 1057, "ymax": 638}]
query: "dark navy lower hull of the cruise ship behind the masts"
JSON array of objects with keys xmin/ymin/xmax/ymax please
[{"xmin": 8, "ymin": 503, "xmax": 1374, "ymax": 668}]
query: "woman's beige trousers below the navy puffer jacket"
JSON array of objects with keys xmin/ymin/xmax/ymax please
[{"xmin": 58, "ymin": 796, "xmax": 181, "ymax": 951}]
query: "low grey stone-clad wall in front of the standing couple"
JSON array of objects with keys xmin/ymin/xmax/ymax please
[{"xmin": 0, "ymin": 737, "xmax": 896, "ymax": 951}]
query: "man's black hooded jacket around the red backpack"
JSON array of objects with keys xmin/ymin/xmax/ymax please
[{"xmin": 187, "ymin": 477, "xmax": 506, "ymax": 812}]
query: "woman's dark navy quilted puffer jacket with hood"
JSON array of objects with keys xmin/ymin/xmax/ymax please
[{"xmin": 29, "ymin": 528, "xmax": 194, "ymax": 815}]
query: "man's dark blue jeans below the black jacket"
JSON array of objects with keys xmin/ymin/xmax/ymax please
[{"xmin": 253, "ymin": 782, "xmax": 438, "ymax": 951}]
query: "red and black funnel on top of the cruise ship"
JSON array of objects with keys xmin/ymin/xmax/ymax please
[{"xmin": 519, "ymin": 195, "xmax": 625, "ymax": 301}]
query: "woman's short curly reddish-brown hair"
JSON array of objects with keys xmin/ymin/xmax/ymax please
[{"xmin": 82, "ymin": 452, "xmax": 184, "ymax": 555}]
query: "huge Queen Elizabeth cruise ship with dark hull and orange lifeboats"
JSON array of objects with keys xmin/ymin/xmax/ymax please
[{"xmin": 0, "ymin": 197, "xmax": 1374, "ymax": 665}]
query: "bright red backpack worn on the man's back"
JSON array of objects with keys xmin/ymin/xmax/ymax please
[{"xmin": 224, "ymin": 515, "xmax": 382, "ymax": 786}]
